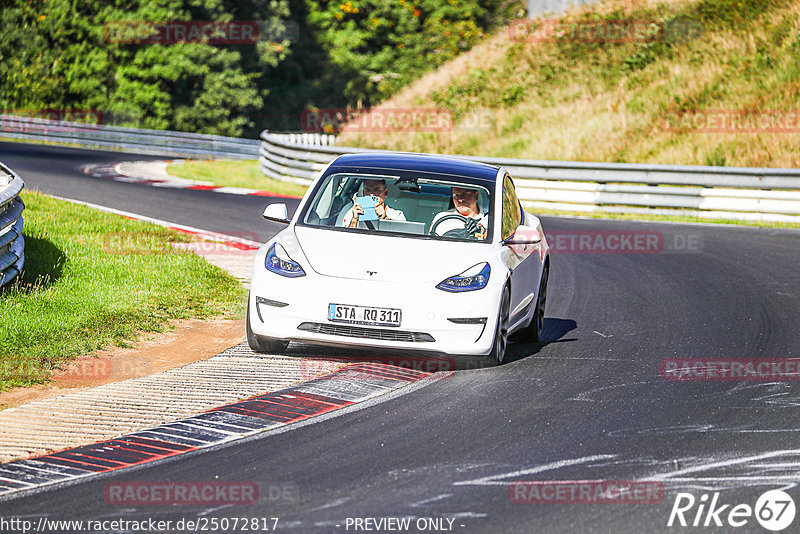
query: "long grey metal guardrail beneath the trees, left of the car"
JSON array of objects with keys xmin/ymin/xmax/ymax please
[{"xmin": 0, "ymin": 114, "xmax": 259, "ymax": 159}]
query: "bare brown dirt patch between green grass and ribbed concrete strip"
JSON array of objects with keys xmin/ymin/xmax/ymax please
[{"xmin": 0, "ymin": 319, "xmax": 245, "ymax": 409}]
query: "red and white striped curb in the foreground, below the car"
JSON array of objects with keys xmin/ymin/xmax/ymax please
[{"xmin": 0, "ymin": 363, "xmax": 431, "ymax": 500}]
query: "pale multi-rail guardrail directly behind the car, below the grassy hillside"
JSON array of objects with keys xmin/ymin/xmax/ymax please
[{"xmin": 259, "ymin": 130, "xmax": 800, "ymax": 223}]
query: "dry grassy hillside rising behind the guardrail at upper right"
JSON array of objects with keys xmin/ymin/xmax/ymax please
[{"xmin": 337, "ymin": 0, "xmax": 800, "ymax": 167}]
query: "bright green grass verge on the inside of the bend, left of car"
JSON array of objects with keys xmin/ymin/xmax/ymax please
[{"xmin": 0, "ymin": 192, "xmax": 245, "ymax": 390}]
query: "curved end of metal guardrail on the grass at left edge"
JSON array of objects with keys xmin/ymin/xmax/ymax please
[{"xmin": 0, "ymin": 163, "xmax": 25, "ymax": 287}]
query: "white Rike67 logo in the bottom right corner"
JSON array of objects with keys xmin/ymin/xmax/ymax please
[{"xmin": 667, "ymin": 490, "xmax": 797, "ymax": 532}]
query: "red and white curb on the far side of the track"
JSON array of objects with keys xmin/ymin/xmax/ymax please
[{"xmin": 83, "ymin": 159, "xmax": 300, "ymax": 199}]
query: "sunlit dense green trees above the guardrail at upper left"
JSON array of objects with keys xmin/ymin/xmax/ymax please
[{"xmin": 0, "ymin": 0, "xmax": 290, "ymax": 136}]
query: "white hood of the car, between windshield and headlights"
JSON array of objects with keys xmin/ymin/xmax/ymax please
[{"xmin": 295, "ymin": 227, "xmax": 490, "ymax": 284}]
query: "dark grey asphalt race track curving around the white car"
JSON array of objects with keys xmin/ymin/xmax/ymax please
[{"xmin": 0, "ymin": 143, "xmax": 800, "ymax": 533}]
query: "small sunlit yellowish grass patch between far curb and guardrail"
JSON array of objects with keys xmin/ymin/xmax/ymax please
[{"xmin": 167, "ymin": 160, "xmax": 307, "ymax": 197}]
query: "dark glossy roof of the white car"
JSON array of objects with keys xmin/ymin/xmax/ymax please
[{"xmin": 328, "ymin": 152, "xmax": 499, "ymax": 185}]
